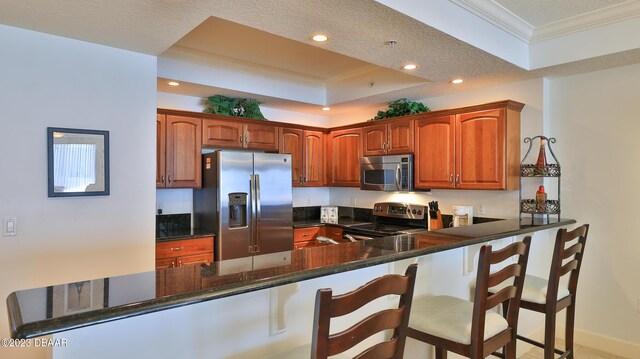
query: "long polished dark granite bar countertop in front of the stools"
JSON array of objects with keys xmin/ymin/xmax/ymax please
[{"xmin": 7, "ymin": 219, "xmax": 576, "ymax": 338}]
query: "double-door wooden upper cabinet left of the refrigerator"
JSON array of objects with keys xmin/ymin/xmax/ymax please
[{"xmin": 156, "ymin": 114, "xmax": 202, "ymax": 188}]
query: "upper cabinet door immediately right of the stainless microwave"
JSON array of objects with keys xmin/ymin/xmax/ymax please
[{"xmin": 414, "ymin": 116, "xmax": 455, "ymax": 188}]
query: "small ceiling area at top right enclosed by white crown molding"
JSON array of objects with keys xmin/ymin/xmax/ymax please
[{"xmin": 494, "ymin": 0, "xmax": 629, "ymax": 26}]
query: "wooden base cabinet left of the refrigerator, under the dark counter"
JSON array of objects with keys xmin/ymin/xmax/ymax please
[{"xmin": 156, "ymin": 236, "xmax": 213, "ymax": 269}]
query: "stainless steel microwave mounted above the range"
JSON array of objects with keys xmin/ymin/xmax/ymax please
[{"xmin": 360, "ymin": 154, "xmax": 413, "ymax": 192}]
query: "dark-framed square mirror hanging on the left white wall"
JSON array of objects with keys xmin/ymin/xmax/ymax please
[{"xmin": 47, "ymin": 127, "xmax": 109, "ymax": 197}]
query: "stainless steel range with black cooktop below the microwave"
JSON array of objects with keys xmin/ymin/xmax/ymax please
[{"xmin": 343, "ymin": 202, "xmax": 428, "ymax": 240}]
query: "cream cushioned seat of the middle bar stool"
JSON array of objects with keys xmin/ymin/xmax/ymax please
[{"xmin": 409, "ymin": 295, "xmax": 508, "ymax": 344}]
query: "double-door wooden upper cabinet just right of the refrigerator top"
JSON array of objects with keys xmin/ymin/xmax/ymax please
[{"xmin": 279, "ymin": 128, "xmax": 324, "ymax": 187}]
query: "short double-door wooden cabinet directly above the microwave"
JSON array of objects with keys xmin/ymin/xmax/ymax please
[{"xmin": 362, "ymin": 118, "xmax": 413, "ymax": 156}]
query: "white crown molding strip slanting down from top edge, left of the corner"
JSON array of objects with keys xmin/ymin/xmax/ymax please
[{"xmin": 449, "ymin": 0, "xmax": 534, "ymax": 43}]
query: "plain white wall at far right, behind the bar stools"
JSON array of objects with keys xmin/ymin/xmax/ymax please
[{"xmin": 549, "ymin": 65, "xmax": 640, "ymax": 350}]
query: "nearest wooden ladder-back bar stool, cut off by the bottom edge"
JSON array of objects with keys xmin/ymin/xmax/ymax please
[{"xmin": 269, "ymin": 264, "xmax": 417, "ymax": 359}]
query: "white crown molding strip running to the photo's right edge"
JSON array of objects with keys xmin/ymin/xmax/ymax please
[{"xmin": 528, "ymin": 0, "xmax": 640, "ymax": 43}]
